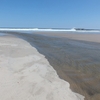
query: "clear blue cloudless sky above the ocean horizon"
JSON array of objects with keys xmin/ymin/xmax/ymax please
[{"xmin": 0, "ymin": 0, "xmax": 100, "ymax": 29}]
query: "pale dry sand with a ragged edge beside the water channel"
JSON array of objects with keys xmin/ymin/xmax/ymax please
[{"xmin": 0, "ymin": 36, "xmax": 84, "ymax": 100}]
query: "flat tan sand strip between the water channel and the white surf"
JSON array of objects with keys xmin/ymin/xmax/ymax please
[{"xmin": 34, "ymin": 32, "xmax": 100, "ymax": 43}]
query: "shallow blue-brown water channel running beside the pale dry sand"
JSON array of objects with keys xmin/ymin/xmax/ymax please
[{"xmin": 1, "ymin": 30, "xmax": 100, "ymax": 100}]
